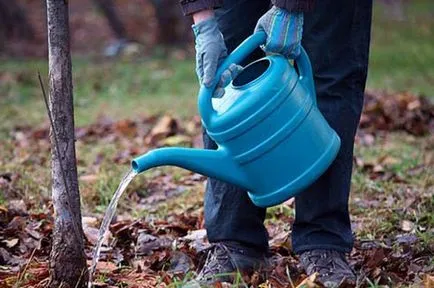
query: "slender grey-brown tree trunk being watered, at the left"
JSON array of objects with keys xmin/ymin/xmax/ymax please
[{"xmin": 47, "ymin": 0, "xmax": 87, "ymax": 288}]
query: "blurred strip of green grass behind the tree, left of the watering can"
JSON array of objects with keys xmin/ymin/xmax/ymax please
[{"xmin": 0, "ymin": 59, "xmax": 197, "ymax": 136}]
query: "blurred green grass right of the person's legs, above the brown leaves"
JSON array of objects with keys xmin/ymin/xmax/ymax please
[{"xmin": 368, "ymin": 0, "xmax": 434, "ymax": 96}]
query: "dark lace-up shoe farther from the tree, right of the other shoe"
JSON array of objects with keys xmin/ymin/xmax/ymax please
[{"xmin": 300, "ymin": 249, "xmax": 356, "ymax": 288}]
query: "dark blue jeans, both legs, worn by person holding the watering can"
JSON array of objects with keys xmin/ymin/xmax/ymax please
[{"xmin": 203, "ymin": 0, "xmax": 372, "ymax": 253}]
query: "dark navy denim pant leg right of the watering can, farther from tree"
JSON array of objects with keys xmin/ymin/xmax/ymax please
[{"xmin": 292, "ymin": 0, "xmax": 372, "ymax": 253}]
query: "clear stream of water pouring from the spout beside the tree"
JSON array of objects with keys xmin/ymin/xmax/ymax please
[{"xmin": 87, "ymin": 170, "xmax": 137, "ymax": 288}]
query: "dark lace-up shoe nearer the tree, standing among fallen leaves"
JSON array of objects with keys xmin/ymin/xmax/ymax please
[{"xmin": 183, "ymin": 242, "xmax": 267, "ymax": 287}]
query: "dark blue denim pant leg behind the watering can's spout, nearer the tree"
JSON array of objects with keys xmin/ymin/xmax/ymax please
[{"xmin": 203, "ymin": 0, "xmax": 269, "ymax": 250}]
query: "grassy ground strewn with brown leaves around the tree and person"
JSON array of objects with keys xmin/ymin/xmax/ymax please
[{"xmin": 0, "ymin": 1, "xmax": 434, "ymax": 287}]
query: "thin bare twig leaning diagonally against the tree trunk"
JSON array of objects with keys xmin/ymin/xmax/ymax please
[{"xmin": 38, "ymin": 71, "xmax": 82, "ymax": 241}]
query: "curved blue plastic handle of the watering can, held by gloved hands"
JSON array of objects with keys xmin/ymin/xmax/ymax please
[{"xmin": 198, "ymin": 31, "xmax": 316, "ymax": 128}]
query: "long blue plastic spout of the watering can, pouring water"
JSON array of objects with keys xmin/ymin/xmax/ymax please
[{"xmin": 131, "ymin": 147, "xmax": 248, "ymax": 189}]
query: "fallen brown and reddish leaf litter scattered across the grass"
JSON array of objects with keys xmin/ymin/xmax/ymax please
[{"xmin": 0, "ymin": 92, "xmax": 434, "ymax": 288}]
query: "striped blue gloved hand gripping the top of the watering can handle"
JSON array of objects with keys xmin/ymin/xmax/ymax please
[{"xmin": 255, "ymin": 6, "xmax": 303, "ymax": 59}]
